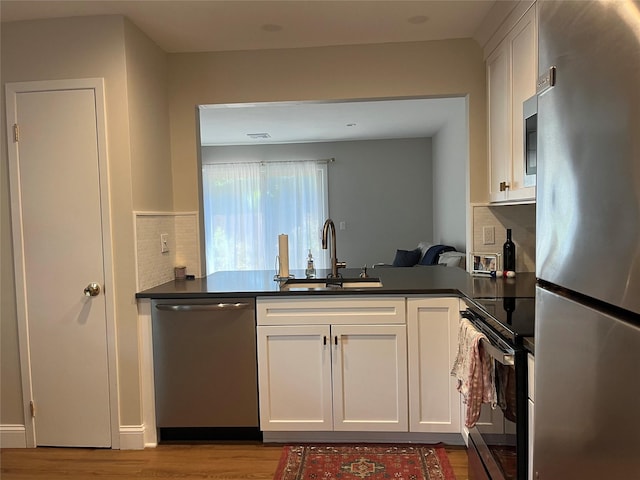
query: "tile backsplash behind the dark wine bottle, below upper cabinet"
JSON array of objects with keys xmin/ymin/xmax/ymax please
[{"xmin": 473, "ymin": 204, "xmax": 536, "ymax": 272}]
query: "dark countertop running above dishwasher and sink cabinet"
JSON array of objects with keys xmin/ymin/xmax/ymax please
[{"xmin": 136, "ymin": 266, "xmax": 535, "ymax": 299}]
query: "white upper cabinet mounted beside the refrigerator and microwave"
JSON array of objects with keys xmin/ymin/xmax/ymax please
[{"xmin": 487, "ymin": 4, "xmax": 538, "ymax": 202}]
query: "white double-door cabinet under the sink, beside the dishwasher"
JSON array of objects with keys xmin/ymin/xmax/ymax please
[{"xmin": 257, "ymin": 297, "xmax": 408, "ymax": 432}]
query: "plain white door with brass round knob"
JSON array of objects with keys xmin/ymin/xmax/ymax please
[{"xmin": 7, "ymin": 82, "xmax": 112, "ymax": 447}]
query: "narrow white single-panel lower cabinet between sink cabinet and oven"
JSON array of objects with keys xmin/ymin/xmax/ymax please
[{"xmin": 407, "ymin": 297, "xmax": 461, "ymax": 433}]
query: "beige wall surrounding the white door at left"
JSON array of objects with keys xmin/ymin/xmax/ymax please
[{"xmin": 0, "ymin": 16, "xmax": 173, "ymax": 425}]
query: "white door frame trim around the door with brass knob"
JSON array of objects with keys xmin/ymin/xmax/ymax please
[{"xmin": 5, "ymin": 78, "xmax": 120, "ymax": 449}]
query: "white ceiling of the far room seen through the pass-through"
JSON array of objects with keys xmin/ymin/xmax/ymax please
[{"xmin": 200, "ymin": 98, "xmax": 464, "ymax": 145}]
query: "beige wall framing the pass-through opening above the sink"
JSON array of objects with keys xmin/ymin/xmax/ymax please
[{"xmin": 169, "ymin": 39, "xmax": 487, "ymax": 210}]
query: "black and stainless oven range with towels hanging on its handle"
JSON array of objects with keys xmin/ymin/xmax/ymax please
[{"xmin": 461, "ymin": 297, "xmax": 535, "ymax": 480}]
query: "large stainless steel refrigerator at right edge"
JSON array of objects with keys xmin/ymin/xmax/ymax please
[{"xmin": 533, "ymin": 0, "xmax": 640, "ymax": 480}]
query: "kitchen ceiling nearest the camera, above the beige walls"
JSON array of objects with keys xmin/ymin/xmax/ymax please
[{"xmin": 0, "ymin": 0, "xmax": 495, "ymax": 52}]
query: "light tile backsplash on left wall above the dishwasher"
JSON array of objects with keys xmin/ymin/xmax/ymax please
[{"xmin": 134, "ymin": 212, "xmax": 201, "ymax": 291}]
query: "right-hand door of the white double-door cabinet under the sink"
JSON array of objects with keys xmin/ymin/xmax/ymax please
[{"xmin": 331, "ymin": 325, "xmax": 409, "ymax": 432}]
